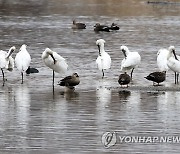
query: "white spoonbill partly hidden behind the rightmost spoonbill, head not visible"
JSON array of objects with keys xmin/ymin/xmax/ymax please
[{"xmin": 157, "ymin": 49, "xmax": 169, "ymax": 72}]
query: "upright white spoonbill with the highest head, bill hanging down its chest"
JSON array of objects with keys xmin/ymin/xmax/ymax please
[{"xmin": 96, "ymin": 39, "xmax": 111, "ymax": 78}]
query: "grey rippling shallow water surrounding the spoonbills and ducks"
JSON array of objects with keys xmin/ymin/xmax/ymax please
[{"xmin": 0, "ymin": 0, "xmax": 180, "ymax": 154}]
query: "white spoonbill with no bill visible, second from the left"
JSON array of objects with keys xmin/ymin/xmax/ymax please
[{"xmin": 15, "ymin": 44, "xmax": 31, "ymax": 84}]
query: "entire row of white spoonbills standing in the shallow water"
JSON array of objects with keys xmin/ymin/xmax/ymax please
[{"xmin": 0, "ymin": 39, "xmax": 180, "ymax": 88}]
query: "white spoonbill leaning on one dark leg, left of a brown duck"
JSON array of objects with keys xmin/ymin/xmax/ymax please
[{"xmin": 42, "ymin": 48, "xmax": 68, "ymax": 86}]
